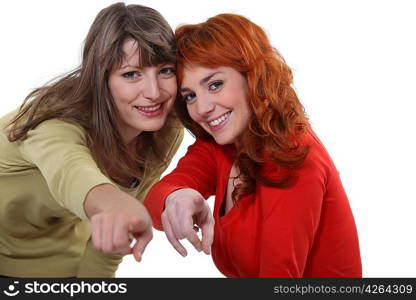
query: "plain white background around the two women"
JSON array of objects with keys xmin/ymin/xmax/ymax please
[{"xmin": 0, "ymin": 0, "xmax": 416, "ymax": 277}]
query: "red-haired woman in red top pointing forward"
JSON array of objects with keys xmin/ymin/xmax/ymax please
[{"xmin": 145, "ymin": 14, "xmax": 362, "ymax": 277}]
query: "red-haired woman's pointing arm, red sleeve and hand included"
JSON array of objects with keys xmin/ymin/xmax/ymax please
[{"xmin": 145, "ymin": 139, "xmax": 217, "ymax": 256}]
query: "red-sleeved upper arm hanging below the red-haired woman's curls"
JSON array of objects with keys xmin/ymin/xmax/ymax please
[{"xmin": 259, "ymin": 161, "xmax": 326, "ymax": 277}]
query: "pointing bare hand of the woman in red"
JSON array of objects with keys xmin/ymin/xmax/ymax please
[{"xmin": 161, "ymin": 189, "xmax": 214, "ymax": 256}]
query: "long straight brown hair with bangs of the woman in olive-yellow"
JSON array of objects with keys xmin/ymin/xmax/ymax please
[{"xmin": 8, "ymin": 3, "xmax": 176, "ymax": 182}]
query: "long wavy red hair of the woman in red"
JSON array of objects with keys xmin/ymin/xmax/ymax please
[{"xmin": 175, "ymin": 14, "xmax": 309, "ymax": 202}]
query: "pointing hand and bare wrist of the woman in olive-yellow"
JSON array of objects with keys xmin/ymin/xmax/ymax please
[{"xmin": 84, "ymin": 184, "xmax": 153, "ymax": 262}]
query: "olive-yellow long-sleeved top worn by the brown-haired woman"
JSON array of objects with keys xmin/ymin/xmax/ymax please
[{"xmin": 0, "ymin": 112, "xmax": 183, "ymax": 277}]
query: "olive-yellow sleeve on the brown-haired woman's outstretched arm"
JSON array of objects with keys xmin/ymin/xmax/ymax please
[{"xmin": 19, "ymin": 119, "xmax": 113, "ymax": 221}]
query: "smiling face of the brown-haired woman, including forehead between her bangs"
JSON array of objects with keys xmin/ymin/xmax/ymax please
[{"xmin": 108, "ymin": 39, "xmax": 177, "ymax": 144}]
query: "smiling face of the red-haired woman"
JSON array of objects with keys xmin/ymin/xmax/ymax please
[{"xmin": 181, "ymin": 66, "xmax": 251, "ymax": 145}]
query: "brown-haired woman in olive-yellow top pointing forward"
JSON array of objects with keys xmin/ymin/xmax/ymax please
[{"xmin": 0, "ymin": 3, "xmax": 183, "ymax": 277}]
